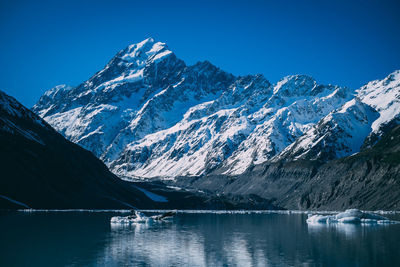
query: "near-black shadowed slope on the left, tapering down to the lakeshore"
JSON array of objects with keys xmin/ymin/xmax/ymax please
[{"xmin": 0, "ymin": 91, "xmax": 276, "ymax": 209}]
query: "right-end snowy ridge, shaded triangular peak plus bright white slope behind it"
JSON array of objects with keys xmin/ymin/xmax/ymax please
[{"xmin": 273, "ymin": 71, "xmax": 400, "ymax": 161}]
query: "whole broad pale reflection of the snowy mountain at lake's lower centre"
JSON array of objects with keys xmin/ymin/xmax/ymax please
[{"xmin": 104, "ymin": 223, "xmax": 268, "ymax": 266}]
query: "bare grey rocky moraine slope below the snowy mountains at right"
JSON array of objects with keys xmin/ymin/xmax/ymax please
[{"xmin": 172, "ymin": 125, "xmax": 400, "ymax": 210}]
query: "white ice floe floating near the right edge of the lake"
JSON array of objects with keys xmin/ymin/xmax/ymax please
[{"xmin": 307, "ymin": 209, "xmax": 400, "ymax": 225}]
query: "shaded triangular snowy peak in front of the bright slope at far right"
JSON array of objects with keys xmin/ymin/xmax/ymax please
[{"xmin": 274, "ymin": 99, "xmax": 379, "ymax": 161}]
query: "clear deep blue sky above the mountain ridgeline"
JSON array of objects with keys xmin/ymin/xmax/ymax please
[{"xmin": 0, "ymin": 0, "xmax": 400, "ymax": 107}]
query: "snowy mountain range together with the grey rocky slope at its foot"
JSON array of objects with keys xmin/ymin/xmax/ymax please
[{"xmin": 28, "ymin": 38, "xmax": 400, "ymax": 209}]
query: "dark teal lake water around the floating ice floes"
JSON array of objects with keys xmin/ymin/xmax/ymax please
[{"xmin": 0, "ymin": 212, "xmax": 400, "ymax": 266}]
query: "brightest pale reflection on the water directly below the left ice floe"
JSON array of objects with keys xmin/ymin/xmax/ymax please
[{"xmin": 102, "ymin": 223, "xmax": 205, "ymax": 266}]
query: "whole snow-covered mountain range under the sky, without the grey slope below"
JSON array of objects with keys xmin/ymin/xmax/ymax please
[{"xmin": 33, "ymin": 38, "xmax": 400, "ymax": 177}]
